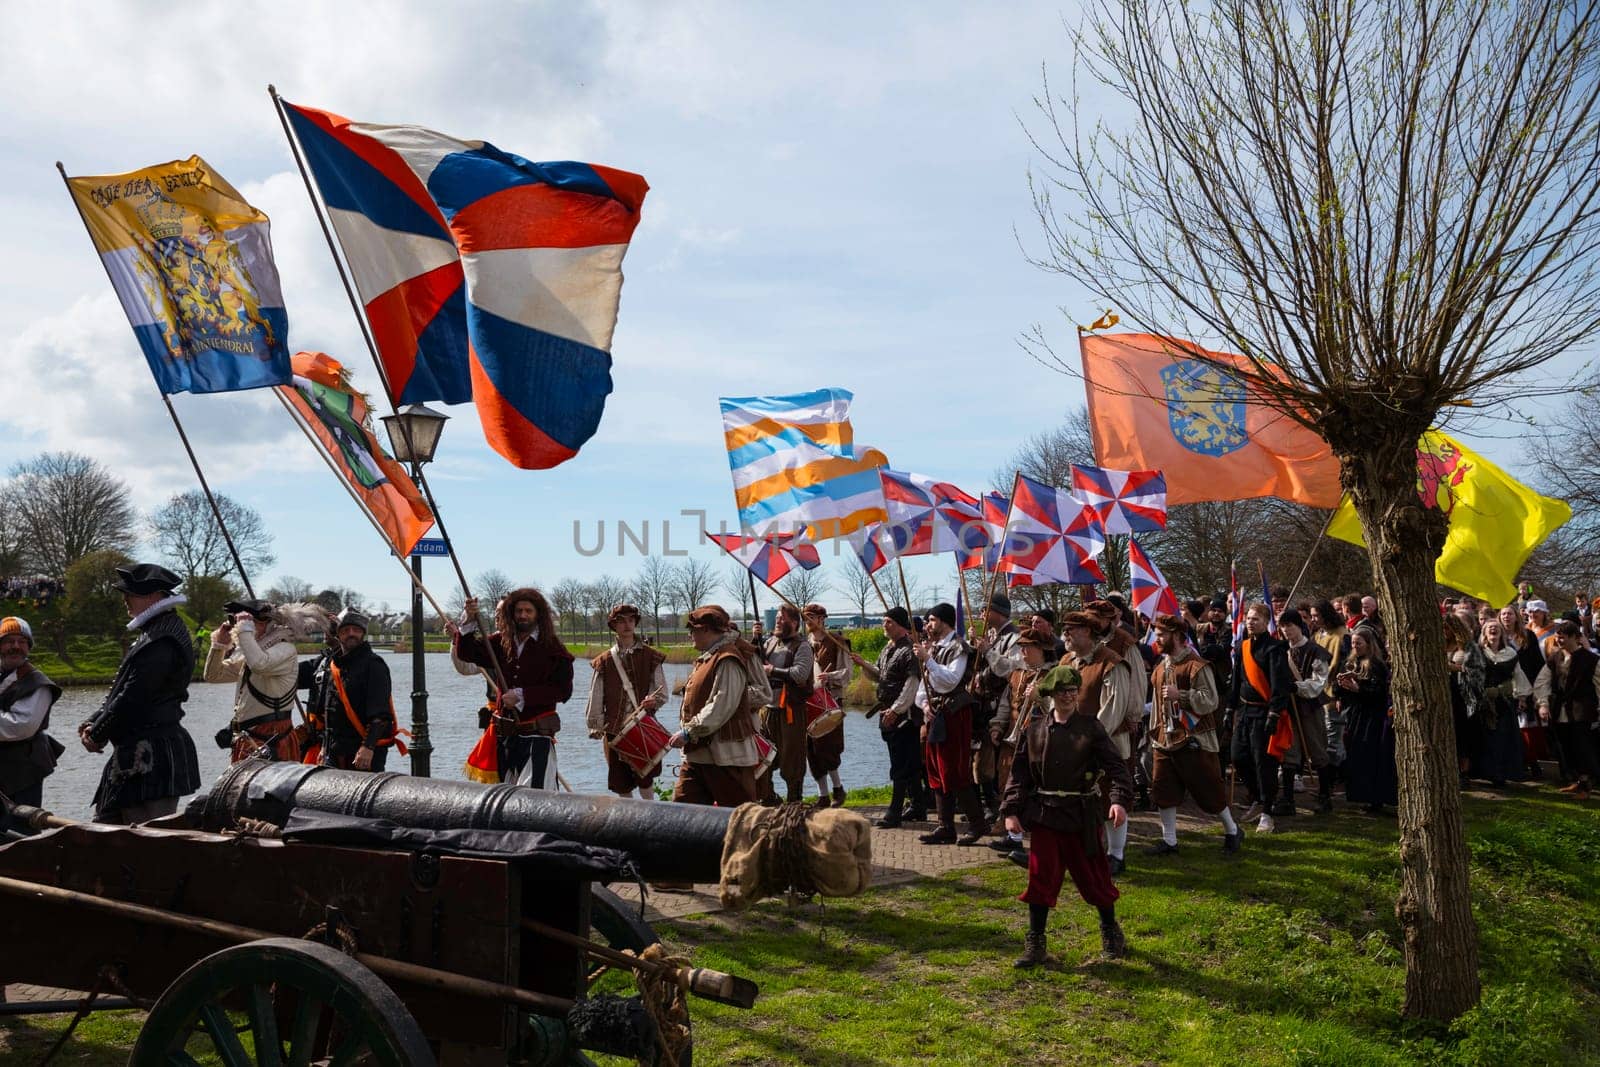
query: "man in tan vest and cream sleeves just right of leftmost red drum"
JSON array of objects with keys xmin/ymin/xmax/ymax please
[{"xmin": 672, "ymin": 605, "xmax": 771, "ymax": 808}]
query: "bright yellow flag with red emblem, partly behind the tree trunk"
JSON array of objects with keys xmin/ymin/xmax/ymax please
[{"xmin": 1328, "ymin": 430, "xmax": 1573, "ymax": 608}]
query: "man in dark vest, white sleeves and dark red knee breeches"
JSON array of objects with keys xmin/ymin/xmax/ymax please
[{"xmin": 912, "ymin": 603, "xmax": 989, "ymax": 845}]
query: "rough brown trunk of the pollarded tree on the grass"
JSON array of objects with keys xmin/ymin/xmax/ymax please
[{"xmin": 1339, "ymin": 438, "xmax": 1480, "ymax": 1021}]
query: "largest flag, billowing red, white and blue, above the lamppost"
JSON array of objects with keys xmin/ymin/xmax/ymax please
[{"xmin": 282, "ymin": 101, "xmax": 648, "ymax": 469}]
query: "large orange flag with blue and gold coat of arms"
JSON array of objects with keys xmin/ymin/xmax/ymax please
[{"xmin": 1078, "ymin": 333, "xmax": 1341, "ymax": 507}]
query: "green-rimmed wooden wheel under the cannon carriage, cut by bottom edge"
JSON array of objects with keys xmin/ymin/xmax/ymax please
[{"xmin": 130, "ymin": 937, "xmax": 435, "ymax": 1067}]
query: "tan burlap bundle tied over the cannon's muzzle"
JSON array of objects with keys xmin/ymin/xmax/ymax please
[{"xmin": 722, "ymin": 805, "xmax": 872, "ymax": 910}]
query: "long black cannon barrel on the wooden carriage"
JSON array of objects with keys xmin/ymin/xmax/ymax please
[{"xmin": 187, "ymin": 760, "xmax": 733, "ymax": 883}]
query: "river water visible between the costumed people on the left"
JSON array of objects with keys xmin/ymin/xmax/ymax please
[{"xmin": 45, "ymin": 651, "xmax": 890, "ymax": 819}]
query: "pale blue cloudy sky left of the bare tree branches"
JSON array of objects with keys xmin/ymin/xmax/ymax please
[{"xmin": 0, "ymin": 0, "xmax": 1574, "ymax": 617}]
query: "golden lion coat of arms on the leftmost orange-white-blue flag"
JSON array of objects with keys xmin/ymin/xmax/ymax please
[{"xmin": 134, "ymin": 192, "xmax": 277, "ymax": 358}]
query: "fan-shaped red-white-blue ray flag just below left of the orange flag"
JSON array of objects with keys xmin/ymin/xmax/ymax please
[{"xmin": 995, "ymin": 475, "xmax": 1106, "ymax": 585}]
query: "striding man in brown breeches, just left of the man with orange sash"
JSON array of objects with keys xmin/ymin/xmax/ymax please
[{"xmin": 1149, "ymin": 614, "xmax": 1245, "ymax": 856}]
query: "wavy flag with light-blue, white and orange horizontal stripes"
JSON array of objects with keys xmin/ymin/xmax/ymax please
[{"xmin": 720, "ymin": 389, "xmax": 888, "ymax": 541}]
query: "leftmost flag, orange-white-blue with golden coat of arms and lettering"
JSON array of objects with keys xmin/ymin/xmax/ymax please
[{"xmin": 67, "ymin": 155, "xmax": 290, "ymax": 394}]
